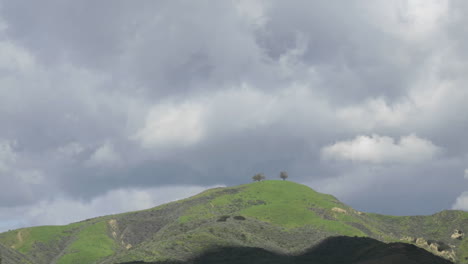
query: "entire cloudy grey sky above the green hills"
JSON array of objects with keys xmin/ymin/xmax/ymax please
[{"xmin": 0, "ymin": 0, "xmax": 468, "ymax": 231}]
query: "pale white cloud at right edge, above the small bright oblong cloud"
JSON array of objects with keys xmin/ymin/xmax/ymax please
[{"xmin": 335, "ymin": 60, "xmax": 468, "ymax": 135}]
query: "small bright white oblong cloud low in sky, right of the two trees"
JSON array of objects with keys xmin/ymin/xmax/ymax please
[{"xmin": 321, "ymin": 135, "xmax": 440, "ymax": 164}]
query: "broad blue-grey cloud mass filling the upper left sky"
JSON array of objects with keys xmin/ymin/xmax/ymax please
[{"xmin": 2, "ymin": 0, "xmax": 269, "ymax": 98}]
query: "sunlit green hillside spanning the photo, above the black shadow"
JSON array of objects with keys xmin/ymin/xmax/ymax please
[{"xmin": 0, "ymin": 180, "xmax": 468, "ymax": 264}]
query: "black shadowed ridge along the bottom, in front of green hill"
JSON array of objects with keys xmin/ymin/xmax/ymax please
[{"xmin": 120, "ymin": 236, "xmax": 452, "ymax": 264}]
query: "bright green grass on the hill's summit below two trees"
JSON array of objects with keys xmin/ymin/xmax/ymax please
[{"xmin": 179, "ymin": 180, "xmax": 365, "ymax": 236}]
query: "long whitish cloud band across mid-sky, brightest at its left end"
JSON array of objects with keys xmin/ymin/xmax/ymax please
[{"xmin": 132, "ymin": 83, "xmax": 334, "ymax": 149}]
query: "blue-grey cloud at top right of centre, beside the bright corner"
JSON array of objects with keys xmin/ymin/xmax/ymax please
[{"xmin": 259, "ymin": 1, "xmax": 427, "ymax": 104}]
